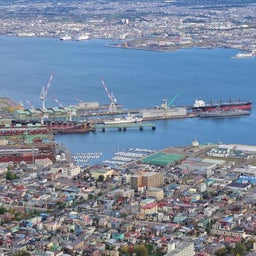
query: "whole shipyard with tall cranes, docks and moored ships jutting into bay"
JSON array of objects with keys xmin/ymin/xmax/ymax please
[{"xmin": 0, "ymin": 73, "xmax": 252, "ymax": 166}]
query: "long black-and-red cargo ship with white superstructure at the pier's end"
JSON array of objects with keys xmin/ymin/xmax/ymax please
[{"xmin": 192, "ymin": 100, "xmax": 252, "ymax": 112}]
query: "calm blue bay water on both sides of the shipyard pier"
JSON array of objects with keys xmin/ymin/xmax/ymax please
[{"xmin": 0, "ymin": 37, "xmax": 256, "ymax": 163}]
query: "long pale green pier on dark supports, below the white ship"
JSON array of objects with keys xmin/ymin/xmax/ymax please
[{"xmin": 96, "ymin": 123, "xmax": 156, "ymax": 132}]
